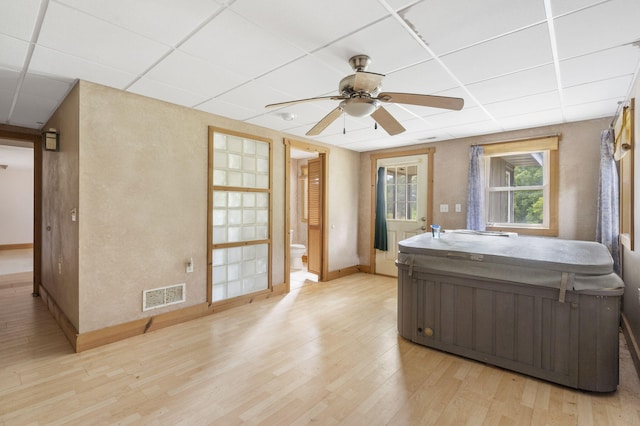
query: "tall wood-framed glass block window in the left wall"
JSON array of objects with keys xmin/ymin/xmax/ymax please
[{"xmin": 209, "ymin": 129, "xmax": 271, "ymax": 302}]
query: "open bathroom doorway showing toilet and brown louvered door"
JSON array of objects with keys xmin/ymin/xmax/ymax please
[{"xmin": 285, "ymin": 140, "xmax": 328, "ymax": 291}]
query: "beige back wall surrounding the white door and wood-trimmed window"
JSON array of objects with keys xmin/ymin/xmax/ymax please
[{"xmin": 358, "ymin": 119, "xmax": 611, "ymax": 265}]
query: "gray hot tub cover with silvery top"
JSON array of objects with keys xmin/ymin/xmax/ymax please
[{"xmin": 398, "ymin": 231, "xmax": 624, "ymax": 291}]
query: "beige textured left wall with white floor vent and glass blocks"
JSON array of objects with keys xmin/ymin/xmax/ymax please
[{"xmin": 43, "ymin": 81, "xmax": 359, "ymax": 333}]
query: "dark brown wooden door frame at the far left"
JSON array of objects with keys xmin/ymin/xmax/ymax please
[{"xmin": 0, "ymin": 125, "xmax": 42, "ymax": 297}]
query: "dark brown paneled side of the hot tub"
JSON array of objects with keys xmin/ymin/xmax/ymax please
[{"xmin": 398, "ymin": 265, "xmax": 620, "ymax": 392}]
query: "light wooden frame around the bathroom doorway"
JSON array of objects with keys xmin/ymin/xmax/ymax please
[{"xmin": 283, "ymin": 138, "xmax": 329, "ymax": 292}]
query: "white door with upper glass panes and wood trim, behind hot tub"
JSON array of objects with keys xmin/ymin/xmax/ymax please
[{"xmin": 370, "ymin": 148, "xmax": 435, "ymax": 277}]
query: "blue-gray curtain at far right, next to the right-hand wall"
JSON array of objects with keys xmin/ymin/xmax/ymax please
[{"xmin": 596, "ymin": 129, "xmax": 619, "ymax": 273}]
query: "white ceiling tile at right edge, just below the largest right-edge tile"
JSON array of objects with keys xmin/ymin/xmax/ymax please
[{"xmin": 560, "ymin": 45, "xmax": 640, "ymax": 87}]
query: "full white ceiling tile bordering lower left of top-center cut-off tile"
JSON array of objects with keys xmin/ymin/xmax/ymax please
[{"xmin": 181, "ymin": 9, "xmax": 304, "ymax": 78}]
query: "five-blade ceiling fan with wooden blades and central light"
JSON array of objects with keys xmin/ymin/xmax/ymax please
[{"xmin": 266, "ymin": 55, "xmax": 464, "ymax": 136}]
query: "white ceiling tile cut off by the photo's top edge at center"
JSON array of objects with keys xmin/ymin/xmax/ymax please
[{"xmin": 231, "ymin": 0, "xmax": 387, "ymax": 53}]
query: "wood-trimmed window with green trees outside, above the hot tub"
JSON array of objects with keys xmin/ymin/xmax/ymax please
[{"xmin": 484, "ymin": 136, "xmax": 558, "ymax": 236}]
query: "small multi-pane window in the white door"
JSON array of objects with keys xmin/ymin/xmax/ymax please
[{"xmin": 386, "ymin": 165, "xmax": 418, "ymax": 221}]
